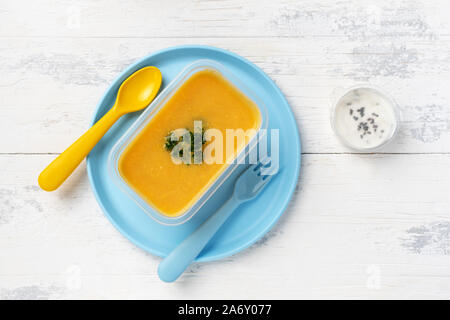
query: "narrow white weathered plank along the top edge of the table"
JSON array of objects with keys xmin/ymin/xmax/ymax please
[{"xmin": 0, "ymin": 0, "xmax": 450, "ymax": 40}]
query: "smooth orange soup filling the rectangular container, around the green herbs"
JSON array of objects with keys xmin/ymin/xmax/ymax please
[{"xmin": 119, "ymin": 70, "xmax": 261, "ymax": 217}]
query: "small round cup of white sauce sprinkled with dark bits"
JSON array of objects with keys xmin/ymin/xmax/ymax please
[{"xmin": 333, "ymin": 88, "xmax": 397, "ymax": 150}]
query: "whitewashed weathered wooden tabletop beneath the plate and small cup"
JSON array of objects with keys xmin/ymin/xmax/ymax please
[{"xmin": 0, "ymin": 0, "xmax": 450, "ymax": 299}]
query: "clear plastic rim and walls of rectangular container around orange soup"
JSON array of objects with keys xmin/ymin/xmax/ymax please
[{"xmin": 108, "ymin": 60, "xmax": 268, "ymax": 225}]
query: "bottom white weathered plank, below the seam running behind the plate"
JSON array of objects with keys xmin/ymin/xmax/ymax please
[{"xmin": 0, "ymin": 154, "xmax": 450, "ymax": 299}]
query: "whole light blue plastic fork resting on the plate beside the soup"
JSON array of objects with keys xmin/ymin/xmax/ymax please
[{"xmin": 158, "ymin": 162, "xmax": 274, "ymax": 282}]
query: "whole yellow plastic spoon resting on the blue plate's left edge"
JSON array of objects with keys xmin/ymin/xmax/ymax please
[{"xmin": 38, "ymin": 67, "xmax": 162, "ymax": 191}]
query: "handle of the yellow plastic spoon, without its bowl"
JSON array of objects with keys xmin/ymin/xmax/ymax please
[{"xmin": 38, "ymin": 107, "xmax": 120, "ymax": 191}]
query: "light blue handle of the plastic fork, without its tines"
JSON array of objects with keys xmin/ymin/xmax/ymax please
[{"xmin": 158, "ymin": 197, "xmax": 240, "ymax": 282}]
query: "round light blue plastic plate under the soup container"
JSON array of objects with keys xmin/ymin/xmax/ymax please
[{"xmin": 87, "ymin": 46, "xmax": 301, "ymax": 261}]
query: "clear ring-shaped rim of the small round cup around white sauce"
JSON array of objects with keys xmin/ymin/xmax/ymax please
[{"xmin": 330, "ymin": 85, "xmax": 401, "ymax": 152}]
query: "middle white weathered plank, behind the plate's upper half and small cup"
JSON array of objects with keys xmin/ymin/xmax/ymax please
[{"xmin": 0, "ymin": 37, "xmax": 450, "ymax": 153}]
